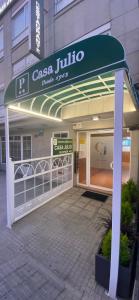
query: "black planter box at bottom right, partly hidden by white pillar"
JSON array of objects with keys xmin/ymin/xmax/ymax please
[{"xmin": 95, "ymin": 242, "xmax": 137, "ymax": 298}]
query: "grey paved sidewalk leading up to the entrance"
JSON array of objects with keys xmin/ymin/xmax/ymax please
[{"xmin": 0, "ymin": 175, "xmax": 116, "ymax": 300}]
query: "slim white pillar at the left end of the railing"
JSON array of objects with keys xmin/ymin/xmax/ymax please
[{"xmin": 5, "ymin": 107, "xmax": 12, "ymax": 228}]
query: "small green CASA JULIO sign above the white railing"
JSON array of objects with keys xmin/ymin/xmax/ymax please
[{"xmin": 52, "ymin": 138, "xmax": 73, "ymax": 155}]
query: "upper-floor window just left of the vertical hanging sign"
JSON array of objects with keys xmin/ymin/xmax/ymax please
[{"xmin": 12, "ymin": 3, "xmax": 29, "ymax": 46}]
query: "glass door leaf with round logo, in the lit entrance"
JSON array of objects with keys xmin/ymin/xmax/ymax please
[{"xmin": 90, "ymin": 133, "xmax": 113, "ymax": 190}]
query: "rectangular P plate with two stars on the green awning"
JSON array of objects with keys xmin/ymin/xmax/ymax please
[{"xmin": 16, "ymin": 73, "xmax": 29, "ymax": 98}]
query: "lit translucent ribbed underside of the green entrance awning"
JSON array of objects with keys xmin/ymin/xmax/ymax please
[{"xmin": 9, "ymin": 72, "xmax": 122, "ymax": 118}]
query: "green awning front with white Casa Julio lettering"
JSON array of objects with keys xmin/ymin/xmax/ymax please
[{"xmin": 5, "ymin": 35, "xmax": 127, "ymax": 104}]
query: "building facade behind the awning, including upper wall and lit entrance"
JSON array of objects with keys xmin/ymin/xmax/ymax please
[{"xmin": 0, "ymin": 0, "xmax": 139, "ymax": 190}]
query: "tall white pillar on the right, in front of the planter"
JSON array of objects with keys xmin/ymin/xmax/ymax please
[{"xmin": 109, "ymin": 70, "xmax": 124, "ymax": 299}]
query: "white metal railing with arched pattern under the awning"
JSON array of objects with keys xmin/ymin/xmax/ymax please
[{"xmin": 7, "ymin": 154, "xmax": 73, "ymax": 224}]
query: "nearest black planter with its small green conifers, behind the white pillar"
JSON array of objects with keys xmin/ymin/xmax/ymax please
[{"xmin": 95, "ymin": 230, "xmax": 137, "ymax": 298}]
